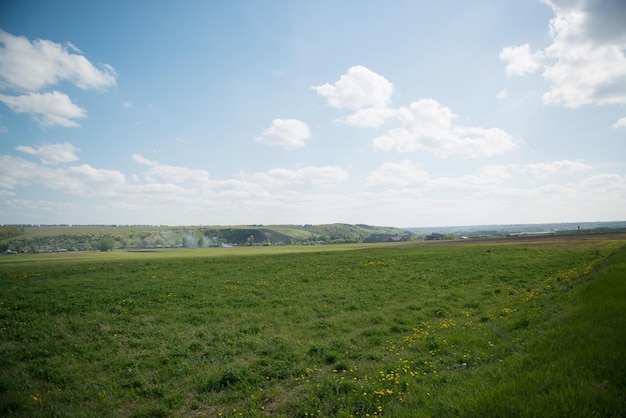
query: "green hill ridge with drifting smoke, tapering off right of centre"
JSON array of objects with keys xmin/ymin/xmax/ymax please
[{"xmin": 0, "ymin": 224, "xmax": 414, "ymax": 252}]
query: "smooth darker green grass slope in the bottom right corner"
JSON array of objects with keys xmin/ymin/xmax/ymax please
[{"xmin": 458, "ymin": 243, "xmax": 626, "ymax": 417}]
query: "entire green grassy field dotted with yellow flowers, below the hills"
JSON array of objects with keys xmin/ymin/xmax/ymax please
[{"xmin": 0, "ymin": 236, "xmax": 626, "ymax": 417}]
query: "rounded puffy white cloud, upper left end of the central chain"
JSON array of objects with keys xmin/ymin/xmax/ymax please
[{"xmin": 311, "ymin": 65, "xmax": 393, "ymax": 109}]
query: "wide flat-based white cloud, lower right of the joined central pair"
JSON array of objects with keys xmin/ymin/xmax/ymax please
[{"xmin": 373, "ymin": 99, "xmax": 517, "ymax": 158}]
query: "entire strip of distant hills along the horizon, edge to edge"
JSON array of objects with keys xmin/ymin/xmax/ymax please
[{"xmin": 0, "ymin": 221, "xmax": 626, "ymax": 252}]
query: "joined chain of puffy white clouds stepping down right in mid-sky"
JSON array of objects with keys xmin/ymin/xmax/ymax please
[{"xmin": 313, "ymin": 66, "xmax": 517, "ymax": 158}]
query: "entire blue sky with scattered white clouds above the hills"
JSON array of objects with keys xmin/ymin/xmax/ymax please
[{"xmin": 0, "ymin": 0, "xmax": 626, "ymax": 227}]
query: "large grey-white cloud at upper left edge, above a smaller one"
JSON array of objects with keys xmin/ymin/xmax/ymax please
[{"xmin": 0, "ymin": 29, "xmax": 116, "ymax": 91}]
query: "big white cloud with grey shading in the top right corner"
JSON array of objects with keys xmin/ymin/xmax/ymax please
[{"xmin": 500, "ymin": 0, "xmax": 626, "ymax": 108}]
